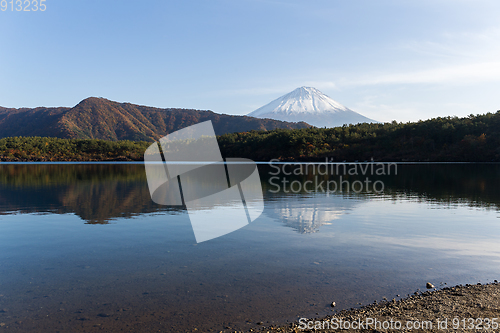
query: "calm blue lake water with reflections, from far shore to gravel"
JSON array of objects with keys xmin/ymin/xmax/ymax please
[{"xmin": 0, "ymin": 164, "xmax": 500, "ymax": 332}]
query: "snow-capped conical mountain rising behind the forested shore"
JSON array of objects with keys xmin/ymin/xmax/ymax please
[{"xmin": 248, "ymin": 87, "xmax": 378, "ymax": 127}]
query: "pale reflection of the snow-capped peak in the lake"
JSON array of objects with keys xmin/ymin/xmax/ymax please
[{"xmin": 264, "ymin": 195, "xmax": 359, "ymax": 234}]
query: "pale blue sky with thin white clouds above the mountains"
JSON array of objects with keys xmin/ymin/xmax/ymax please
[{"xmin": 0, "ymin": 0, "xmax": 500, "ymax": 122}]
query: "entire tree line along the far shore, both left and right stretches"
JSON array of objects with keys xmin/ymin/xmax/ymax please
[{"xmin": 0, "ymin": 111, "xmax": 500, "ymax": 162}]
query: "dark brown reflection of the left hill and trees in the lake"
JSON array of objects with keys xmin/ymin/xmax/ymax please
[{"xmin": 0, "ymin": 164, "xmax": 183, "ymax": 223}]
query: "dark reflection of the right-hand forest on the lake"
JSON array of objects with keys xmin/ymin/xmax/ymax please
[{"xmin": 259, "ymin": 163, "xmax": 500, "ymax": 209}]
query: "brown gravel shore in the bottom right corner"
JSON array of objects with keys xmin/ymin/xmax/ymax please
[{"xmin": 252, "ymin": 280, "xmax": 500, "ymax": 333}]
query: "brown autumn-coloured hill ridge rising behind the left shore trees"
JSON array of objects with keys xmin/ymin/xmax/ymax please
[{"xmin": 0, "ymin": 97, "xmax": 311, "ymax": 141}]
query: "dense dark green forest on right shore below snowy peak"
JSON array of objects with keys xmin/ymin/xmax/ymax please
[{"xmin": 219, "ymin": 111, "xmax": 500, "ymax": 162}]
